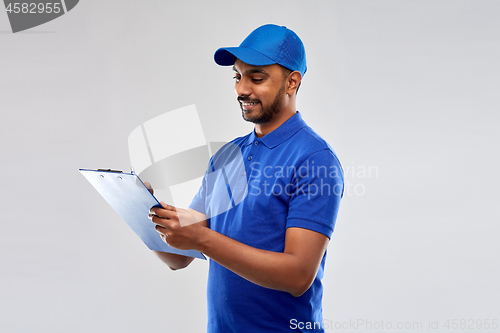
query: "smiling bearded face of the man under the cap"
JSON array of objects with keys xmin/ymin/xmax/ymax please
[{"xmin": 233, "ymin": 59, "xmax": 285, "ymax": 124}]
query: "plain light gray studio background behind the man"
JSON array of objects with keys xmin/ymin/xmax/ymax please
[{"xmin": 0, "ymin": 0, "xmax": 500, "ymax": 332}]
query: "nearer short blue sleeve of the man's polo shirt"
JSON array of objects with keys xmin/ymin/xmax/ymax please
[{"xmin": 286, "ymin": 149, "xmax": 344, "ymax": 238}]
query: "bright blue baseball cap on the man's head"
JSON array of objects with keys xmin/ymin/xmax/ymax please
[{"xmin": 214, "ymin": 24, "xmax": 307, "ymax": 76}]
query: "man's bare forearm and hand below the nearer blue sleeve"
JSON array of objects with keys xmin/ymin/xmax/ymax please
[{"xmin": 151, "ymin": 203, "xmax": 329, "ymax": 296}]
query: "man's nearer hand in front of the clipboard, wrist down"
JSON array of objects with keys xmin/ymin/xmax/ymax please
[{"xmin": 149, "ymin": 202, "xmax": 208, "ymax": 251}]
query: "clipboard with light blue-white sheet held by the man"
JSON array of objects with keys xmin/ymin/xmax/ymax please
[{"xmin": 79, "ymin": 169, "xmax": 206, "ymax": 260}]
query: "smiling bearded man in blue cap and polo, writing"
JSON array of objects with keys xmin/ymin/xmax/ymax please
[{"xmin": 150, "ymin": 25, "xmax": 343, "ymax": 333}]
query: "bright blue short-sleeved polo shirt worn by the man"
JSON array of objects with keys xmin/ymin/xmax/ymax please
[{"xmin": 190, "ymin": 112, "xmax": 344, "ymax": 333}]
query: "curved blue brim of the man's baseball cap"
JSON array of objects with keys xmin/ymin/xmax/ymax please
[{"xmin": 214, "ymin": 46, "xmax": 276, "ymax": 66}]
